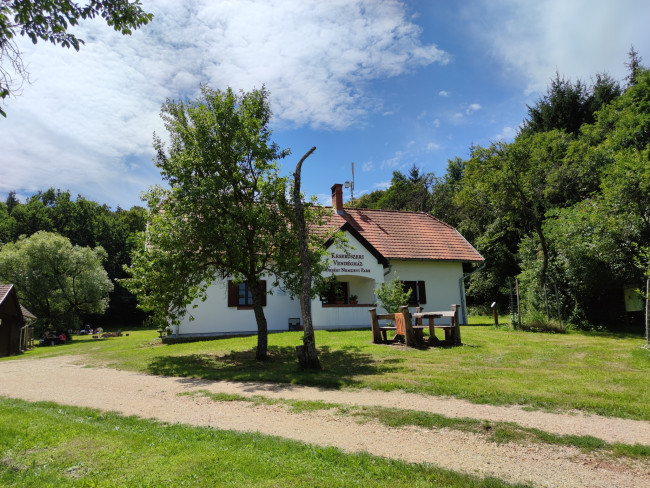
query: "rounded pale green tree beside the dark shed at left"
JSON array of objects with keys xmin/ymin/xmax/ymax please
[{"xmin": 0, "ymin": 231, "xmax": 113, "ymax": 327}]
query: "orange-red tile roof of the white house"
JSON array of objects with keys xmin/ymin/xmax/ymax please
[{"xmin": 318, "ymin": 207, "xmax": 484, "ymax": 263}]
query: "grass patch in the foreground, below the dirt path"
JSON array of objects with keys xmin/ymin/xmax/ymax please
[{"xmin": 0, "ymin": 398, "xmax": 524, "ymax": 488}]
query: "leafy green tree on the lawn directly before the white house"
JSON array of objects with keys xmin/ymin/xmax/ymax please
[{"xmin": 125, "ymin": 86, "xmax": 308, "ymax": 360}]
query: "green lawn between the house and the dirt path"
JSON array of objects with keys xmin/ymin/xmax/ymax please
[{"xmin": 6, "ymin": 318, "xmax": 650, "ymax": 420}]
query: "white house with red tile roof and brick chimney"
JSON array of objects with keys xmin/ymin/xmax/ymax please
[{"xmin": 174, "ymin": 184, "xmax": 483, "ymax": 336}]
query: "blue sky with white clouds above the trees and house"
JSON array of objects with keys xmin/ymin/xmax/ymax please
[{"xmin": 0, "ymin": 0, "xmax": 650, "ymax": 208}]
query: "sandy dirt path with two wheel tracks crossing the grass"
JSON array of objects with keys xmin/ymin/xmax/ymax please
[{"xmin": 0, "ymin": 356, "xmax": 650, "ymax": 488}]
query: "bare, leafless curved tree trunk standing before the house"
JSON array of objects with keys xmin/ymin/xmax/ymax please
[{"xmin": 293, "ymin": 147, "xmax": 322, "ymax": 370}]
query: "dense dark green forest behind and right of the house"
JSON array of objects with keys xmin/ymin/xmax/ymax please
[{"xmin": 354, "ymin": 56, "xmax": 650, "ymax": 331}]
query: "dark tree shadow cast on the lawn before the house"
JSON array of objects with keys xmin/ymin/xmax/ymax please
[{"xmin": 147, "ymin": 346, "xmax": 399, "ymax": 388}]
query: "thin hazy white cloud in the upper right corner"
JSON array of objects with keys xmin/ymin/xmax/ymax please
[{"xmin": 464, "ymin": 0, "xmax": 650, "ymax": 93}]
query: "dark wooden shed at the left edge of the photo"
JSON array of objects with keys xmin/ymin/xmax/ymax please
[{"xmin": 0, "ymin": 285, "xmax": 35, "ymax": 356}]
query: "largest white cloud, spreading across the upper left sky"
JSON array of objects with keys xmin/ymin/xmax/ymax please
[{"xmin": 0, "ymin": 0, "xmax": 448, "ymax": 205}]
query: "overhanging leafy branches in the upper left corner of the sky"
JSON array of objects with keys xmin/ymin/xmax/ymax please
[{"xmin": 0, "ymin": 0, "xmax": 153, "ymax": 116}]
